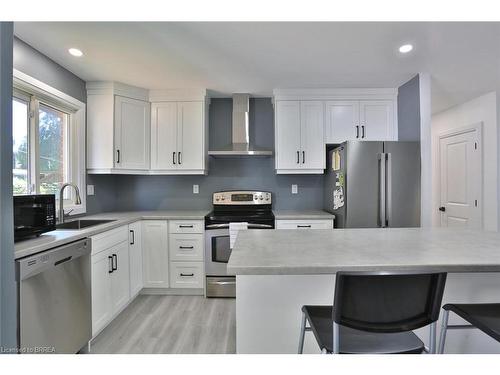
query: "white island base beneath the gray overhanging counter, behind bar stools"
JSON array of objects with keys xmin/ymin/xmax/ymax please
[{"xmin": 236, "ymin": 272, "xmax": 500, "ymax": 354}]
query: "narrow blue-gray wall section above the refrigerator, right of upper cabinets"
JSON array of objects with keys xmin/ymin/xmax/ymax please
[{"xmin": 398, "ymin": 75, "xmax": 420, "ymax": 141}]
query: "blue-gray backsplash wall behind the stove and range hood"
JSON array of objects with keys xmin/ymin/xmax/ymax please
[{"xmin": 87, "ymin": 98, "xmax": 326, "ymax": 213}]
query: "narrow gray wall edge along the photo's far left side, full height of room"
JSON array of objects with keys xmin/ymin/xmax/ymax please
[{"xmin": 0, "ymin": 22, "xmax": 17, "ymax": 349}]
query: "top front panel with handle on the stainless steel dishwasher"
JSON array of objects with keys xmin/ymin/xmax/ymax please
[{"xmin": 16, "ymin": 238, "xmax": 92, "ymax": 281}]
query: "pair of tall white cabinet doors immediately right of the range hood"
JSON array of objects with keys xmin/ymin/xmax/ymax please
[{"xmin": 275, "ymin": 100, "xmax": 325, "ymax": 174}]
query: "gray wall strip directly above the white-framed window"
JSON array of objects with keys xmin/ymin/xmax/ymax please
[{"xmin": 14, "ymin": 38, "xmax": 87, "ymax": 103}]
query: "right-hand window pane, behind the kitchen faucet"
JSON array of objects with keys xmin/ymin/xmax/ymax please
[{"xmin": 38, "ymin": 104, "xmax": 69, "ymax": 194}]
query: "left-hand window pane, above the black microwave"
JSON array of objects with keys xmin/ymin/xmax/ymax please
[{"xmin": 12, "ymin": 98, "xmax": 29, "ymax": 195}]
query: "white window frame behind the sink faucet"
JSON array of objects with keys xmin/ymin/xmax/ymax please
[{"xmin": 13, "ymin": 69, "xmax": 87, "ymax": 215}]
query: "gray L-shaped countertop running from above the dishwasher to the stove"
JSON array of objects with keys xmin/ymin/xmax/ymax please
[{"xmin": 14, "ymin": 210, "xmax": 208, "ymax": 259}]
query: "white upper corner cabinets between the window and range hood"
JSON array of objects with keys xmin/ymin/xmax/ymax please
[{"xmin": 87, "ymin": 82, "xmax": 208, "ymax": 174}]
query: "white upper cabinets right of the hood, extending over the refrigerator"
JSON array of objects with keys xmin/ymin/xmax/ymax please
[{"xmin": 274, "ymin": 88, "xmax": 398, "ymax": 173}]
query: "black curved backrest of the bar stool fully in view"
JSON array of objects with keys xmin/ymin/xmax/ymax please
[{"xmin": 333, "ymin": 272, "xmax": 446, "ymax": 333}]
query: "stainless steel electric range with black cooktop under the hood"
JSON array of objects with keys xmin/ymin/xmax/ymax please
[{"xmin": 205, "ymin": 191, "xmax": 274, "ymax": 297}]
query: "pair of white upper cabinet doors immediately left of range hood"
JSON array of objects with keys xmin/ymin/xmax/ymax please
[{"xmin": 151, "ymin": 97, "xmax": 207, "ymax": 174}]
